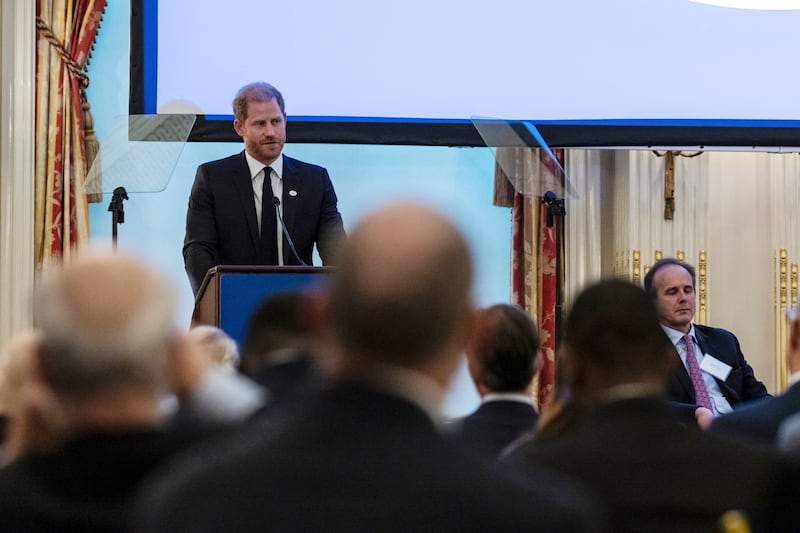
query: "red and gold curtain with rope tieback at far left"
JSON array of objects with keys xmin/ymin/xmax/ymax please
[{"xmin": 34, "ymin": 0, "xmax": 106, "ymax": 268}]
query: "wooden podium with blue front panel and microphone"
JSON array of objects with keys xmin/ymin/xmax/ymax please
[{"xmin": 192, "ymin": 265, "xmax": 333, "ymax": 345}]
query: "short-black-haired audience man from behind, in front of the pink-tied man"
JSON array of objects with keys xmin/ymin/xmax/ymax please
[{"xmin": 498, "ymin": 279, "xmax": 797, "ymax": 533}]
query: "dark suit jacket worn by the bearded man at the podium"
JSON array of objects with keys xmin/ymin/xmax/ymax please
[{"xmin": 183, "ymin": 151, "xmax": 344, "ymax": 293}]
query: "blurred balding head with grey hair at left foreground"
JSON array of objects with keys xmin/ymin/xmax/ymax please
[{"xmin": 34, "ymin": 249, "xmax": 181, "ymax": 424}]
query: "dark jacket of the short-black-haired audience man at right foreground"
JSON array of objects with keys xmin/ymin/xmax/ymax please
[{"xmin": 501, "ymin": 398, "xmax": 783, "ymax": 532}]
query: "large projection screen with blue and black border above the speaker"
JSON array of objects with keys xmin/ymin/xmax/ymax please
[{"xmin": 131, "ymin": 0, "xmax": 800, "ymax": 149}]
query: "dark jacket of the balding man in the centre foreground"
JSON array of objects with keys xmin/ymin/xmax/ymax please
[{"xmin": 142, "ymin": 383, "xmax": 608, "ymax": 532}]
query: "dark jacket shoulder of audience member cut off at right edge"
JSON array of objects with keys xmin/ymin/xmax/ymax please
[{"xmin": 710, "ymin": 383, "xmax": 800, "ymax": 446}]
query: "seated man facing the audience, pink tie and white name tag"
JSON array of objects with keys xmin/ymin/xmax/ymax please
[{"xmin": 644, "ymin": 258, "xmax": 769, "ymax": 427}]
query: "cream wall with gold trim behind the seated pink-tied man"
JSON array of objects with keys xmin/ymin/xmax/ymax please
[{"xmin": 566, "ymin": 150, "xmax": 784, "ymax": 393}]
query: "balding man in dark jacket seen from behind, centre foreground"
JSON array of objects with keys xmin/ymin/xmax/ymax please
[{"xmin": 143, "ymin": 203, "xmax": 597, "ymax": 531}]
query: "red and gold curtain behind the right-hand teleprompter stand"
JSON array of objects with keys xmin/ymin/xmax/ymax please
[{"xmin": 495, "ymin": 148, "xmax": 564, "ymax": 408}]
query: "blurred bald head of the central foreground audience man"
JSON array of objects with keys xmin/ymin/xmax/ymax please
[{"xmin": 329, "ymin": 203, "xmax": 472, "ymax": 380}]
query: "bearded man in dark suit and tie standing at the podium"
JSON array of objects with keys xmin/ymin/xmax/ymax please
[{"xmin": 183, "ymin": 82, "xmax": 345, "ymax": 295}]
